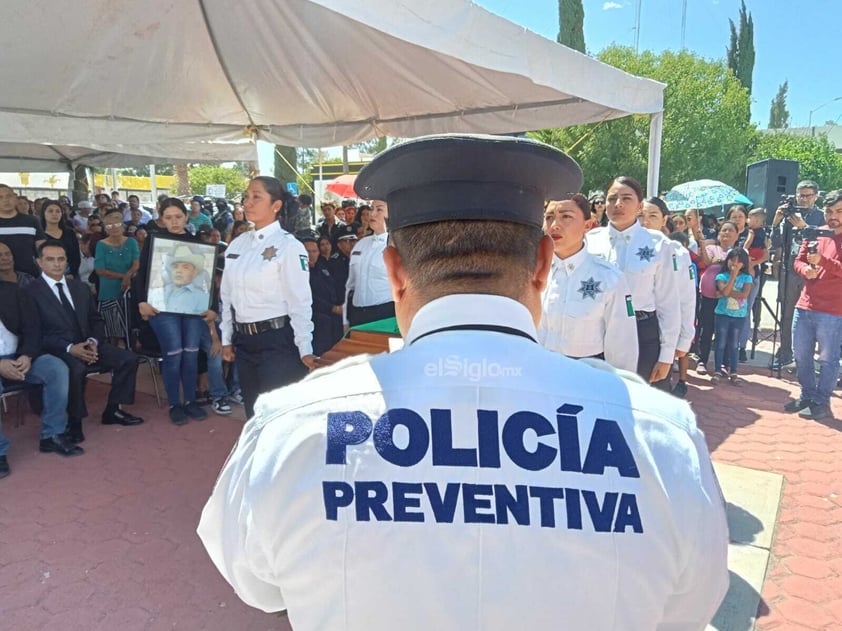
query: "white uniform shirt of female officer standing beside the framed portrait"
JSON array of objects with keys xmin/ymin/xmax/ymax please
[{"xmin": 220, "ymin": 221, "xmax": 313, "ymax": 357}]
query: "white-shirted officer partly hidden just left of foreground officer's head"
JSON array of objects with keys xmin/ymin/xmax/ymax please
[{"xmin": 343, "ymin": 199, "xmax": 395, "ymax": 326}]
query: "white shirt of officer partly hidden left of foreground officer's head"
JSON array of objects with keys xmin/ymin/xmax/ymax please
[{"xmin": 342, "ymin": 232, "xmax": 392, "ymax": 324}]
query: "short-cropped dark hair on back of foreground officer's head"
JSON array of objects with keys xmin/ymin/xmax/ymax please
[{"xmin": 389, "ymin": 221, "xmax": 543, "ymax": 300}]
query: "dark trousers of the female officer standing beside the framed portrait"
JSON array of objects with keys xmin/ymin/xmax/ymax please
[{"xmin": 233, "ymin": 323, "xmax": 308, "ymax": 418}]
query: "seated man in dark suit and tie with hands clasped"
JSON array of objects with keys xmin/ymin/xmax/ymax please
[{"xmin": 27, "ymin": 239, "xmax": 143, "ymax": 442}]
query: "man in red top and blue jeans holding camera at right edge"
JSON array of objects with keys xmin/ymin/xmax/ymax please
[{"xmin": 784, "ymin": 189, "xmax": 842, "ymax": 420}]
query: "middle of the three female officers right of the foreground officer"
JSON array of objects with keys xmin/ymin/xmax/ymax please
[{"xmin": 587, "ymin": 176, "xmax": 681, "ymax": 391}]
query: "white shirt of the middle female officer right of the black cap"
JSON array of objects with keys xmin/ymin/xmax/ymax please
[{"xmin": 586, "ymin": 223, "xmax": 681, "ymax": 364}]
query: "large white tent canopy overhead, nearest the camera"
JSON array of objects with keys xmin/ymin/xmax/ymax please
[{"xmin": 0, "ymin": 0, "xmax": 664, "ymax": 186}]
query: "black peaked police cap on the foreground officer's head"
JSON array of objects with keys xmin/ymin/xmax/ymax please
[{"xmin": 354, "ymin": 134, "xmax": 583, "ymax": 230}]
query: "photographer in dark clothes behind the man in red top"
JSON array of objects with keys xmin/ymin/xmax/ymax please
[{"xmin": 769, "ymin": 180, "xmax": 824, "ymax": 370}]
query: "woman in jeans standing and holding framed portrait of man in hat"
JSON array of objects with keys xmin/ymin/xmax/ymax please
[{"xmin": 134, "ymin": 198, "xmax": 222, "ymax": 425}]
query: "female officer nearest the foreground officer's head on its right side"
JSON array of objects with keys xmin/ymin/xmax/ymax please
[{"xmin": 538, "ymin": 194, "xmax": 637, "ymax": 372}]
